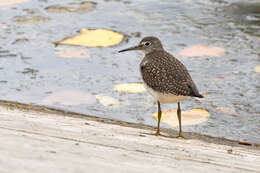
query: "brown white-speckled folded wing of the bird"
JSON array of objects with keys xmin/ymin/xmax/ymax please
[{"xmin": 140, "ymin": 51, "xmax": 200, "ymax": 97}]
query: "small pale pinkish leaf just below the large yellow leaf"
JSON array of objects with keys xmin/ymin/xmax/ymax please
[{"xmin": 55, "ymin": 49, "xmax": 89, "ymax": 58}]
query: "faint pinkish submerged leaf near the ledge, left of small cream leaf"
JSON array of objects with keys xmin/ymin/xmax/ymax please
[{"xmin": 42, "ymin": 90, "xmax": 96, "ymax": 105}]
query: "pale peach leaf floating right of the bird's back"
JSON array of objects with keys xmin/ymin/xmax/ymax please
[{"xmin": 177, "ymin": 45, "xmax": 225, "ymax": 57}]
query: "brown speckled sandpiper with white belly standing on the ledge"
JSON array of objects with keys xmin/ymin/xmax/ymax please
[{"xmin": 119, "ymin": 36, "xmax": 203, "ymax": 138}]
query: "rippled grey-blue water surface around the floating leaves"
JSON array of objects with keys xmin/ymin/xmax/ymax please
[{"xmin": 0, "ymin": 0, "xmax": 260, "ymax": 143}]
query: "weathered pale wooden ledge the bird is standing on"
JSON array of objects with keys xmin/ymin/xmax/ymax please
[{"xmin": 0, "ymin": 102, "xmax": 260, "ymax": 173}]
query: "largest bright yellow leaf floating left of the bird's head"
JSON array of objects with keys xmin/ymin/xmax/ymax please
[{"xmin": 55, "ymin": 29, "xmax": 124, "ymax": 47}]
